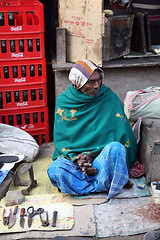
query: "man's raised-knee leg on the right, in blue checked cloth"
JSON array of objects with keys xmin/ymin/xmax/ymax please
[{"xmin": 92, "ymin": 142, "xmax": 129, "ymax": 200}]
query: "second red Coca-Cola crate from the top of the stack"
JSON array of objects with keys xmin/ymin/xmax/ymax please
[{"xmin": 0, "ymin": 33, "xmax": 45, "ymax": 61}]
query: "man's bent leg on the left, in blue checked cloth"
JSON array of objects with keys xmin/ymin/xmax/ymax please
[{"xmin": 47, "ymin": 157, "xmax": 95, "ymax": 195}]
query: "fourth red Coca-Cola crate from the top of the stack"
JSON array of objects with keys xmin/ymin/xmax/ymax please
[{"xmin": 0, "ymin": 83, "xmax": 47, "ymax": 109}]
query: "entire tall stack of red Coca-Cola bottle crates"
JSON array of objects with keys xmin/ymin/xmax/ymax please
[{"xmin": 0, "ymin": 0, "xmax": 49, "ymax": 145}]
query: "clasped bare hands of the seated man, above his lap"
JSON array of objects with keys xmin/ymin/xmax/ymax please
[{"xmin": 77, "ymin": 153, "xmax": 97, "ymax": 175}]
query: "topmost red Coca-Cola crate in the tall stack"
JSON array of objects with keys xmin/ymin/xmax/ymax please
[{"xmin": 0, "ymin": 0, "xmax": 44, "ymax": 35}]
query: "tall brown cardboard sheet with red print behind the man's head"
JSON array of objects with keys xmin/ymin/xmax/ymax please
[{"xmin": 59, "ymin": 0, "xmax": 104, "ymax": 66}]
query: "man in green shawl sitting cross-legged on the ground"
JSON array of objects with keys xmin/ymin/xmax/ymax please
[{"xmin": 48, "ymin": 60, "xmax": 137, "ymax": 201}]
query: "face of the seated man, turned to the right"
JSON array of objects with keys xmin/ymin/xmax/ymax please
[{"xmin": 79, "ymin": 70, "xmax": 102, "ymax": 97}]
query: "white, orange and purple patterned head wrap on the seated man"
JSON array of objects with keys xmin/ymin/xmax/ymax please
[{"xmin": 69, "ymin": 60, "xmax": 103, "ymax": 89}]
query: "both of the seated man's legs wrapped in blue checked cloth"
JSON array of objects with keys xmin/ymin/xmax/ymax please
[{"xmin": 48, "ymin": 142, "xmax": 129, "ymax": 200}]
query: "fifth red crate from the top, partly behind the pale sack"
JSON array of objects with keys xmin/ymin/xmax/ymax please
[{"xmin": 0, "ymin": 106, "xmax": 49, "ymax": 132}]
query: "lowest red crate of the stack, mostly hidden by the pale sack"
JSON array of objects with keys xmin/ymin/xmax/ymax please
[{"xmin": 27, "ymin": 128, "xmax": 49, "ymax": 145}]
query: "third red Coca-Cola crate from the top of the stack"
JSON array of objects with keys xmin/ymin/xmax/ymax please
[{"xmin": 0, "ymin": 58, "xmax": 47, "ymax": 87}]
